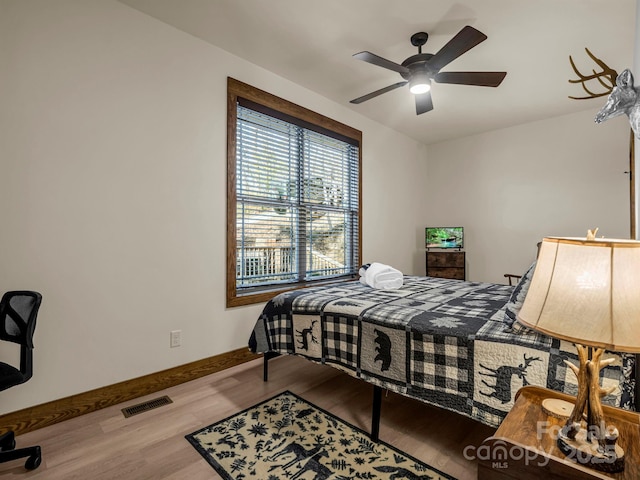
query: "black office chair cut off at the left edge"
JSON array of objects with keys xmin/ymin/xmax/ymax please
[{"xmin": 0, "ymin": 291, "xmax": 42, "ymax": 470}]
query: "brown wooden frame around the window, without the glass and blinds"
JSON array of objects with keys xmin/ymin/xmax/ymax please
[{"xmin": 226, "ymin": 77, "xmax": 362, "ymax": 307}]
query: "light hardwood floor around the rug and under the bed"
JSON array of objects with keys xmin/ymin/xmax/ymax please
[{"xmin": 0, "ymin": 357, "xmax": 494, "ymax": 480}]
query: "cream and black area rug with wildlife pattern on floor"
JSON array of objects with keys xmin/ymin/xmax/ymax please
[{"xmin": 185, "ymin": 391, "xmax": 455, "ymax": 480}]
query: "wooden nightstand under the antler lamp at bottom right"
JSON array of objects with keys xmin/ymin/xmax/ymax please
[{"xmin": 476, "ymin": 386, "xmax": 640, "ymax": 480}]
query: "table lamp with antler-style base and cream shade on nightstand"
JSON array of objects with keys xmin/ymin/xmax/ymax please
[{"xmin": 517, "ymin": 229, "xmax": 640, "ymax": 472}]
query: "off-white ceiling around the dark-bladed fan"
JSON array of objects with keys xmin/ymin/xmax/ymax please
[{"xmin": 120, "ymin": 0, "xmax": 636, "ymax": 144}]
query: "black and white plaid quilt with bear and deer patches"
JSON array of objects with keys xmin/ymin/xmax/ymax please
[{"xmin": 249, "ymin": 276, "xmax": 634, "ymax": 426}]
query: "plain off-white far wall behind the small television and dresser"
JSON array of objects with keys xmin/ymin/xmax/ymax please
[{"xmin": 424, "ymin": 109, "xmax": 630, "ymax": 283}]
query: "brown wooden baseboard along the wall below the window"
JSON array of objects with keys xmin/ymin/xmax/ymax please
[{"xmin": 0, "ymin": 348, "xmax": 259, "ymax": 435}]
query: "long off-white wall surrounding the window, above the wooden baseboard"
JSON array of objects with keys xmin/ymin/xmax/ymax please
[{"xmin": 0, "ymin": 0, "xmax": 426, "ymax": 414}]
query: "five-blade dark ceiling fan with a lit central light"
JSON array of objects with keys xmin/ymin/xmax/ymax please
[{"xmin": 350, "ymin": 25, "xmax": 507, "ymax": 115}]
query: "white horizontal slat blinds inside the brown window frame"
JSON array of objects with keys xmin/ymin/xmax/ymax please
[{"xmin": 236, "ymin": 103, "xmax": 360, "ymax": 290}]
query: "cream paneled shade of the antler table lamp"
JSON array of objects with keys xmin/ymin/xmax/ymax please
[{"xmin": 517, "ymin": 237, "xmax": 640, "ymax": 353}]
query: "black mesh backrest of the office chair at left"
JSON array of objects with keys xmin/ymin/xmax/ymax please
[{"xmin": 0, "ymin": 290, "xmax": 42, "ymax": 383}]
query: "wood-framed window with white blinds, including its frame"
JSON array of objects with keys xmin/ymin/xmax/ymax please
[{"xmin": 227, "ymin": 78, "xmax": 362, "ymax": 306}]
